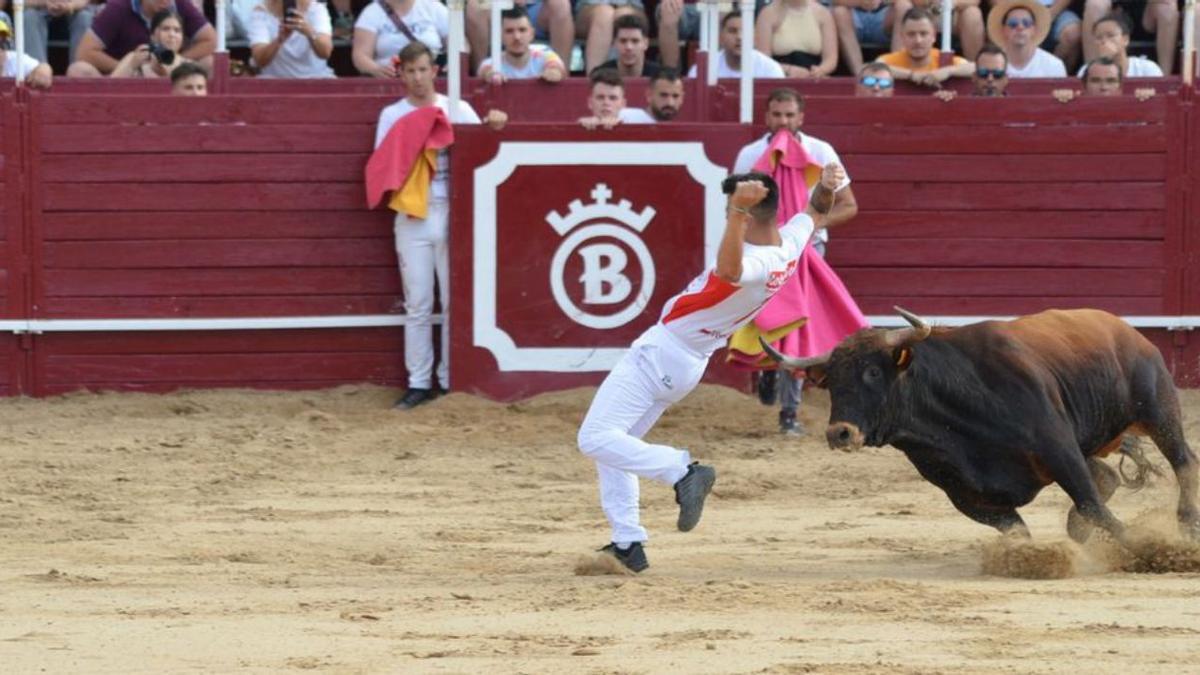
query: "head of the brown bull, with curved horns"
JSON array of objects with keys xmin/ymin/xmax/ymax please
[{"xmin": 763, "ymin": 307, "xmax": 931, "ymax": 450}]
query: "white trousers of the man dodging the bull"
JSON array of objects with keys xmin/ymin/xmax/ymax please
[{"xmin": 578, "ymin": 324, "xmax": 708, "ymax": 544}]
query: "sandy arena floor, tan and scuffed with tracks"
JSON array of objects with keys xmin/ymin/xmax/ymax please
[{"xmin": 0, "ymin": 387, "xmax": 1200, "ymax": 675}]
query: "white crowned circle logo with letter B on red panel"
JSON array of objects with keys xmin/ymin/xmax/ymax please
[{"xmin": 546, "ymin": 183, "xmax": 655, "ymax": 329}]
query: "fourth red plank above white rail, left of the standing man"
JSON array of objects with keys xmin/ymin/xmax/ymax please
[{"xmin": 42, "ymin": 209, "xmax": 395, "ymax": 241}]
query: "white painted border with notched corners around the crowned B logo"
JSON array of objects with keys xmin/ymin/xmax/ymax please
[{"xmin": 472, "ymin": 142, "xmax": 727, "ymax": 372}]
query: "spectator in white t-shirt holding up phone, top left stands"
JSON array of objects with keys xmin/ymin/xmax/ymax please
[{"xmin": 250, "ymin": 0, "xmax": 334, "ymax": 78}]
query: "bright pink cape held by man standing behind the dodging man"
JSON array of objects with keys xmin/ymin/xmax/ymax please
[{"xmin": 736, "ymin": 132, "xmax": 868, "ymax": 363}]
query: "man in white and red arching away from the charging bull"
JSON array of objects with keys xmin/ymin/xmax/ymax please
[{"xmin": 578, "ymin": 163, "xmax": 842, "ymax": 572}]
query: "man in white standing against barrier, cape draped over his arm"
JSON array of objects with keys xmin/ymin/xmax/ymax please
[{"xmin": 376, "ymin": 41, "xmax": 509, "ymax": 410}]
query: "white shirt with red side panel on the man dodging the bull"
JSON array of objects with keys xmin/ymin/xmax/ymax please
[{"xmin": 659, "ymin": 214, "xmax": 812, "ymax": 356}]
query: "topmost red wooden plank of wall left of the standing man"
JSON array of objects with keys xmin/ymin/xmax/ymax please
[{"xmin": 37, "ymin": 92, "xmax": 397, "ymax": 127}]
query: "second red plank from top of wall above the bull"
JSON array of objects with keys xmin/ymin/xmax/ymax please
[{"xmin": 804, "ymin": 124, "xmax": 1168, "ymax": 153}]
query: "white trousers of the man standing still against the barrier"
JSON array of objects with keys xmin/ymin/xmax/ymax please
[{"xmin": 394, "ymin": 201, "xmax": 450, "ymax": 389}]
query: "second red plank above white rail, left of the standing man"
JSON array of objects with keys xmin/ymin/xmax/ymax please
[{"xmin": 44, "ymin": 267, "xmax": 400, "ymax": 294}]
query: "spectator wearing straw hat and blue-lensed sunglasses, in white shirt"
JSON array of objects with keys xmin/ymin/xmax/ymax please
[{"xmin": 988, "ymin": 0, "xmax": 1079, "ymax": 77}]
